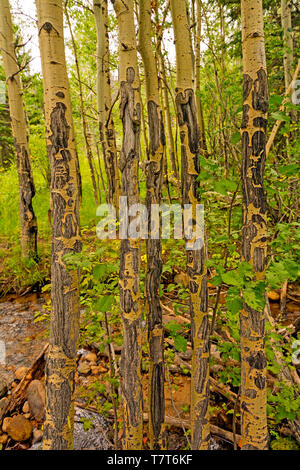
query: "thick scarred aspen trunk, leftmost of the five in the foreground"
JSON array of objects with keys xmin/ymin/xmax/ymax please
[{"xmin": 36, "ymin": 0, "xmax": 81, "ymax": 450}]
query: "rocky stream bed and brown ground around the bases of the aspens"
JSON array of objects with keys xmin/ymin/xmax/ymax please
[{"xmin": 0, "ymin": 276, "xmax": 300, "ymax": 450}]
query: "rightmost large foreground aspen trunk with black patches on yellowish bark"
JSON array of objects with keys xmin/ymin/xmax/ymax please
[{"xmin": 240, "ymin": 0, "xmax": 268, "ymax": 450}]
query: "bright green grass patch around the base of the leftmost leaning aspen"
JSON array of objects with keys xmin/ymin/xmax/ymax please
[{"xmin": 0, "ymin": 152, "xmax": 101, "ymax": 295}]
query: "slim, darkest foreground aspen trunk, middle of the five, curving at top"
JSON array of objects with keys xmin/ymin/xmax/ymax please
[{"xmin": 139, "ymin": 0, "xmax": 166, "ymax": 449}]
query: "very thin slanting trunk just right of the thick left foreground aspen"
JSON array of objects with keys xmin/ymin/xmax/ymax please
[{"xmin": 64, "ymin": 0, "xmax": 99, "ymax": 205}]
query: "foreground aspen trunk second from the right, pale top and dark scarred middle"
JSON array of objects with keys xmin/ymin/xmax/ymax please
[{"xmin": 171, "ymin": 0, "xmax": 210, "ymax": 450}]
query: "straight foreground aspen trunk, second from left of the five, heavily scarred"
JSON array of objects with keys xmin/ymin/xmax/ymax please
[{"xmin": 113, "ymin": 0, "xmax": 143, "ymax": 450}]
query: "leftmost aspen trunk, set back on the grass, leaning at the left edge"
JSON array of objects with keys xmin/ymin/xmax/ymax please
[{"xmin": 0, "ymin": 0, "xmax": 38, "ymax": 258}]
